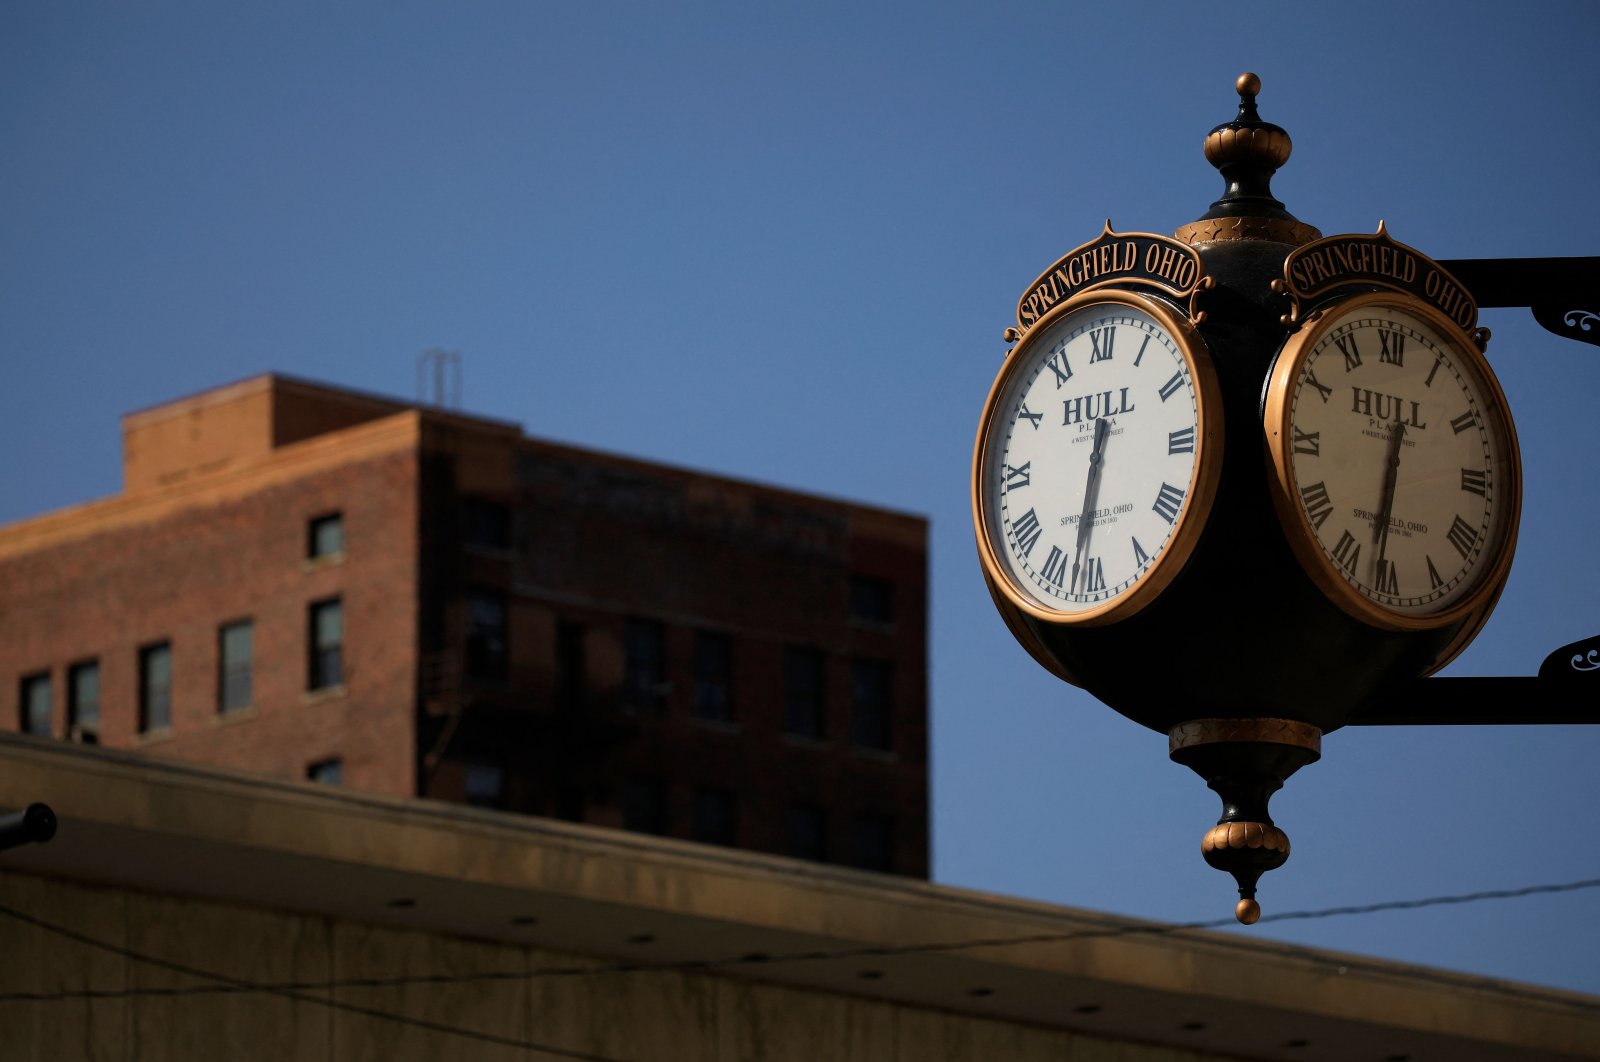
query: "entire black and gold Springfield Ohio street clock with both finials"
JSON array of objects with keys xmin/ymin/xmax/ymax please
[{"xmin": 973, "ymin": 74, "xmax": 1542, "ymax": 924}]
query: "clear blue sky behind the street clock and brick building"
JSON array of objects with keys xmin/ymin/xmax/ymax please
[{"xmin": 0, "ymin": 0, "xmax": 1600, "ymax": 992}]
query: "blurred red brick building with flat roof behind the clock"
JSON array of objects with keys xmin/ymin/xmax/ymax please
[{"xmin": 0, "ymin": 376, "xmax": 928, "ymax": 876}]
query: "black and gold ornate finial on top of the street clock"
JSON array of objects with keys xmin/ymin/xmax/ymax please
[{"xmin": 1176, "ymin": 72, "xmax": 1322, "ymax": 245}]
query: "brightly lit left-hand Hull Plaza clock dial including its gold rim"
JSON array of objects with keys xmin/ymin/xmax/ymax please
[{"xmin": 973, "ymin": 288, "xmax": 1222, "ymax": 625}]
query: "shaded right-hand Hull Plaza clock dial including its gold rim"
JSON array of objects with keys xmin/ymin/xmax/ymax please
[{"xmin": 1262, "ymin": 293, "xmax": 1522, "ymax": 630}]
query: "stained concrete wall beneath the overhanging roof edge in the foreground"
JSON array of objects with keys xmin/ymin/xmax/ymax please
[{"xmin": 0, "ymin": 872, "xmax": 1232, "ymax": 1062}]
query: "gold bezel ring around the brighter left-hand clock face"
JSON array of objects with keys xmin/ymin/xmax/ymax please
[{"xmin": 971, "ymin": 288, "xmax": 1222, "ymax": 627}]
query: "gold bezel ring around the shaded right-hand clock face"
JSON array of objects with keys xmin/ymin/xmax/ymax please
[{"xmin": 1261, "ymin": 291, "xmax": 1522, "ymax": 633}]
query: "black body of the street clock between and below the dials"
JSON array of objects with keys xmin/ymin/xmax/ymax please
[{"xmin": 986, "ymin": 238, "xmax": 1480, "ymax": 734}]
